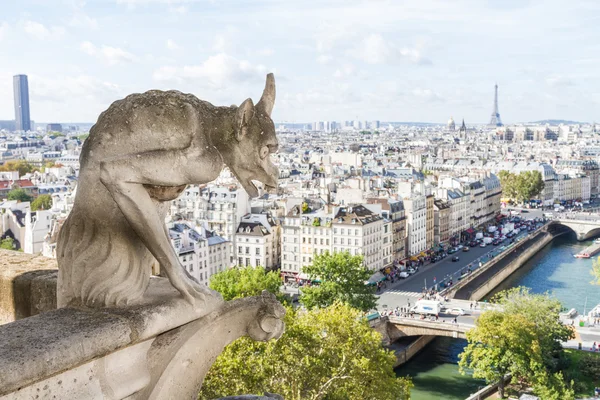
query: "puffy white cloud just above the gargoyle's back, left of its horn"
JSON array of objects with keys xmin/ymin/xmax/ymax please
[{"xmin": 153, "ymin": 53, "xmax": 267, "ymax": 87}]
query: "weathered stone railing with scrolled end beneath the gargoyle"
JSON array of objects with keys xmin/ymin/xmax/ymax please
[{"xmin": 0, "ymin": 251, "xmax": 285, "ymax": 400}]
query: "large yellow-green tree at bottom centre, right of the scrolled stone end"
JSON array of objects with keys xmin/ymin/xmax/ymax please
[{"xmin": 199, "ymin": 303, "xmax": 412, "ymax": 400}]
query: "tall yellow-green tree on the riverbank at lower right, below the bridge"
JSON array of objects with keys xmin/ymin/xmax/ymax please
[{"xmin": 459, "ymin": 288, "xmax": 572, "ymax": 399}]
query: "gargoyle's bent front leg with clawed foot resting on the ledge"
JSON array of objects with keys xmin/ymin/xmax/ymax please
[{"xmin": 100, "ymin": 151, "xmax": 213, "ymax": 304}]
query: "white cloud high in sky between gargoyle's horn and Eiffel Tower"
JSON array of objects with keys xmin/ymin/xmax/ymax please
[{"xmin": 349, "ymin": 33, "xmax": 431, "ymax": 64}]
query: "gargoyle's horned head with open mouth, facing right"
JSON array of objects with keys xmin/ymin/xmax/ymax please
[{"xmin": 222, "ymin": 74, "xmax": 279, "ymax": 197}]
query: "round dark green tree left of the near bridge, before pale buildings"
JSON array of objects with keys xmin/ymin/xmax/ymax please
[{"xmin": 300, "ymin": 252, "xmax": 376, "ymax": 311}]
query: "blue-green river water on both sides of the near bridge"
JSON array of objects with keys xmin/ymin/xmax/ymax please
[{"xmin": 396, "ymin": 234, "xmax": 600, "ymax": 400}]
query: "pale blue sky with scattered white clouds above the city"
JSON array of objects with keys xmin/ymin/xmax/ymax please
[{"xmin": 0, "ymin": 0, "xmax": 600, "ymax": 125}]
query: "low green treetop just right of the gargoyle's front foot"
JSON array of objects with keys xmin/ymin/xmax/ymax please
[{"xmin": 209, "ymin": 267, "xmax": 281, "ymax": 301}]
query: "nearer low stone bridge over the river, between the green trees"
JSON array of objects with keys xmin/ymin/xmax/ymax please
[{"xmin": 375, "ymin": 316, "xmax": 474, "ymax": 343}]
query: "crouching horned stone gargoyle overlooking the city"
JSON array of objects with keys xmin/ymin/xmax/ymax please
[{"xmin": 57, "ymin": 74, "xmax": 278, "ymax": 307}]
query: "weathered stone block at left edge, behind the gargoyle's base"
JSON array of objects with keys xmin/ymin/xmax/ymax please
[{"xmin": 0, "ymin": 249, "xmax": 57, "ymax": 325}]
